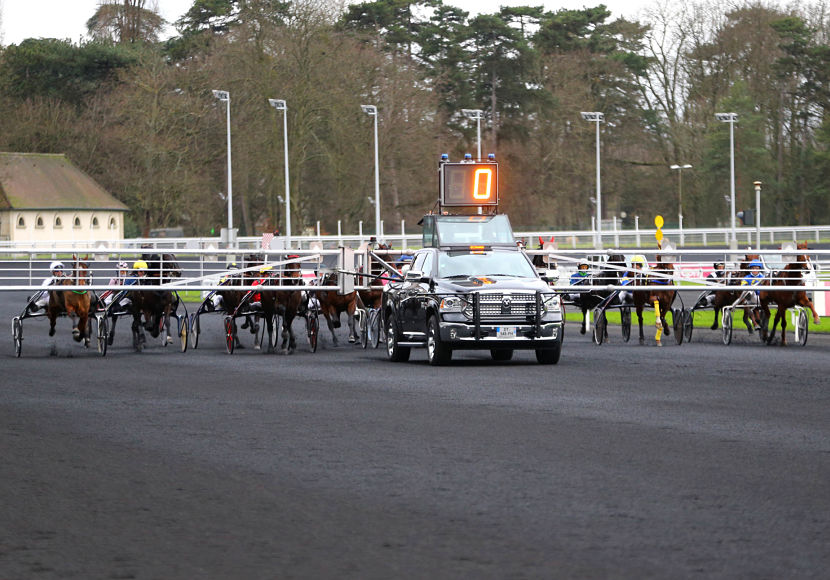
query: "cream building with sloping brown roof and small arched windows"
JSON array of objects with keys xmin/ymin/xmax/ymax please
[{"xmin": 0, "ymin": 152, "xmax": 129, "ymax": 243}]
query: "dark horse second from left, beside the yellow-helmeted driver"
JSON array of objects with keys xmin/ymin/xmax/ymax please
[{"xmin": 130, "ymin": 254, "xmax": 182, "ymax": 351}]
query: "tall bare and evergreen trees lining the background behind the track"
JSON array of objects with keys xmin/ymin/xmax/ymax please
[{"xmin": 0, "ymin": 0, "xmax": 830, "ymax": 235}]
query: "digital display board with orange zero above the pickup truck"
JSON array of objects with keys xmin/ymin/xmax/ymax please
[{"xmin": 440, "ymin": 163, "xmax": 499, "ymax": 206}]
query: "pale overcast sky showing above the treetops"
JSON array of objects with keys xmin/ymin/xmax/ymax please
[{"xmin": 0, "ymin": 0, "xmax": 651, "ymax": 46}]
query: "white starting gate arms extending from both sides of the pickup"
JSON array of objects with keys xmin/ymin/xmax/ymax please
[{"xmin": 0, "ymin": 245, "xmax": 830, "ymax": 295}]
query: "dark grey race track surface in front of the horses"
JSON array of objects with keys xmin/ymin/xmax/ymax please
[{"xmin": 0, "ymin": 293, "xmax": 830, "ymax": 580}]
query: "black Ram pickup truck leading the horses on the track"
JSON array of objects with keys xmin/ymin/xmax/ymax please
[{"xmin": 383, "ymin": 215, "xmax": 563, "ymax": 365}]
